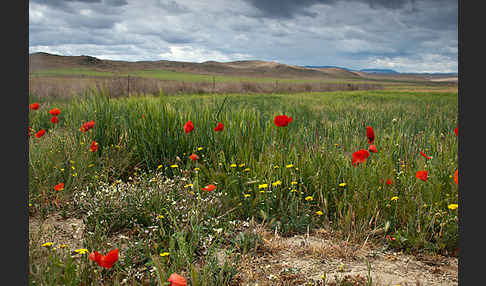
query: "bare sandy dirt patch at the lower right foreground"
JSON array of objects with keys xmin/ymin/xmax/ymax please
[{"xmin": 239, "ymin": 227, "xmax": 458, "ymax": 286}]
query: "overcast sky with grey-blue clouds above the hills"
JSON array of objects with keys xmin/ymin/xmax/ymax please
[{"xmin": 29, "ymin": 0, "xmax": 458, "ymax": 72}]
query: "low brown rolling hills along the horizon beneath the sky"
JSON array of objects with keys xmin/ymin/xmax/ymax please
[{"xmin": 29, "ymin": 52, "xmax": 457, "ymax": 82}]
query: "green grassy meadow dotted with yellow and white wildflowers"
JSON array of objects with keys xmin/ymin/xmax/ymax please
[{"xmin": 28, "ymin": 87, "xmax": 458, "ymax": 285}]
